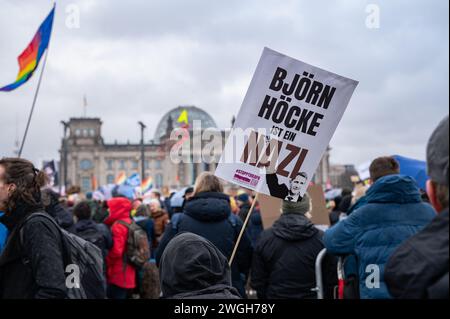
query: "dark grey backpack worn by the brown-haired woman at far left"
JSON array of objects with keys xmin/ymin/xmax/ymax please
[{"xmin": 20, "ymin": 213, "xmax": 106, "ymax": 299}]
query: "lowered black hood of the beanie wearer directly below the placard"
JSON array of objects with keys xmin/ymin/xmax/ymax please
[{"xmin": 272, "ymin": 214, "xmax": 319, "ymax": 241}]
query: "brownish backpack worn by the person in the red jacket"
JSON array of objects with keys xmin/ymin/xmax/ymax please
[{"xmin": 117, "ymin": 220, "xmax": 150, "ymax": 269}]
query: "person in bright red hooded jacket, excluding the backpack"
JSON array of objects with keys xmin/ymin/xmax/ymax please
[{"xmin": 104, "ymin": 197, "xmax": 136, "ymax": 299}]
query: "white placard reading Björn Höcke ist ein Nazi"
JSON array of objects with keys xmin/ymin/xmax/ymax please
[{"xmin": 215, "ymin": 48, "xmax": 358, "ymax": 201}]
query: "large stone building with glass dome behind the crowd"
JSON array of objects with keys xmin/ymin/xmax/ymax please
[{"xmin": 60, "ymin": 107, "xmax": 329, "ymax": 192}]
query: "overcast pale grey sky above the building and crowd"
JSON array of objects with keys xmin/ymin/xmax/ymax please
[{"xmin": 0, "ymin": 0, "xmax": 449, "ymax": 169}]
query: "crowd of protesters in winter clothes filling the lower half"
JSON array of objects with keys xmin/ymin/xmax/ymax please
[{"xmin": 0, "ymin": 117, "xmax": 449, "ymax": 299}]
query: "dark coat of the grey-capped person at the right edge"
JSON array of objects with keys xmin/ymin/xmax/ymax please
[{"xmin": 384, "ymin": 208, "xmax": 449, "ymax": 299}]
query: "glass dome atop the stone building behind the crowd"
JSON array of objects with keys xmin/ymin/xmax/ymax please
[{"xmin": 155, "ymin": 106, "xmax": 217, "ymax": 141}]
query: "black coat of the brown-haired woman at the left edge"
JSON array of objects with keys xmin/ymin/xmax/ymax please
[{"xmin": 0, "ymin": 205, "xmax": 67, "ymax": 299}]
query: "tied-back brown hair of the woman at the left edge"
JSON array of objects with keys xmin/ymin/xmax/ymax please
[{"xmin": 0, "ymin": 157, "xmax": 47, "ymax": 214}]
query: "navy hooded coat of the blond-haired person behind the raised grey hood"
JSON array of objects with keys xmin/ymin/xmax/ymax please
[{"xmin": 156, "ymin": 192, "xmax": 252, "ymax": 296}]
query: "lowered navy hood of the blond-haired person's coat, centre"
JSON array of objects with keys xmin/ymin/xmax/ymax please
[{"xmin": 184, "ymin": 192, "xmax": 231, "ymax": 222}]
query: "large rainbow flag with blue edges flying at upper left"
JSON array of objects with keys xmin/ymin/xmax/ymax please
[{"xmin": 0, "ymin": 7, "xmax": 55, "ymax": 92}]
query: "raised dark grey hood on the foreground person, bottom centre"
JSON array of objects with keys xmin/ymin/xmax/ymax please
[{"xmin": 159, "ymin": 232, "xmax": 236, "ymax": 298}]
